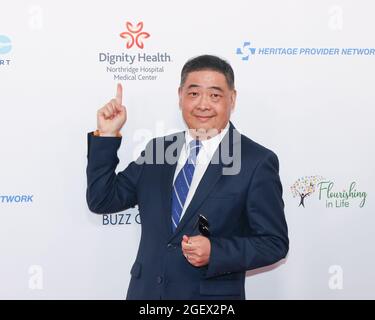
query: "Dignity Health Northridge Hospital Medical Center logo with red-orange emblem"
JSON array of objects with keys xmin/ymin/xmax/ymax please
[{"xmin": 98, "ymin": 21, "xmax": 172, "ymax": 81}]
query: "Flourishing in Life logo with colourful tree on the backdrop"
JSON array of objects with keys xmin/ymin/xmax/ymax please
[{"xmin": 290, "ymin": 176, "xmax": 367, "ymax": 208}]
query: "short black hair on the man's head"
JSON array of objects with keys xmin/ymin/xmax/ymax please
[{"xmin": 180, "ymin": 54, "xmax": 234, "ymax": 89}]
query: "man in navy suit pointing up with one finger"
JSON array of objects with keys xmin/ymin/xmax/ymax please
[{"xmin": 87, "ymin": 55, "xmax": 289, "ymax": 299}]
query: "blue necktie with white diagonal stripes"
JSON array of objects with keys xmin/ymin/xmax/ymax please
[{"xmin": 172, "ymin": 140, "xmax": 202, "ymax": 232}]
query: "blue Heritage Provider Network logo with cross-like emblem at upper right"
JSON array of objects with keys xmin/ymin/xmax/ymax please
[{"xmin": 236, "ymin": 41, "xmax": 375, "ymax": 61}]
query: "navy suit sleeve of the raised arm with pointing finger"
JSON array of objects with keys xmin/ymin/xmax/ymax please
[{"xmin": 86, "ymin": 133, "xmax": 143, "ymax": 214}]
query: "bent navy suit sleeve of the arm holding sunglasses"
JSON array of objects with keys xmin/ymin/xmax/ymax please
[{"xmin": 206, "ymin": 152, "xmax": 289, "ymax": 278}]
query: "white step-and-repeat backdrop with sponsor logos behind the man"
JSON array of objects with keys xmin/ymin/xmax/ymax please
[{"xmin": 0, "ymin": 0, "xmax": 375, "ymax": 299}]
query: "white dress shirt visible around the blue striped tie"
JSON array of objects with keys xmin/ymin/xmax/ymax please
[{"xmin": 173, "ymin": 121, "xmax": 229, "ymax": 221}]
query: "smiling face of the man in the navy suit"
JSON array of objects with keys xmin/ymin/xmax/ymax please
[{"xmin": 178, "ymin": 70, "xmax": 236, "ymax": 135}]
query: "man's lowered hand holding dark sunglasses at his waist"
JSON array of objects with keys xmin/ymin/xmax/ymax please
[{"xmin": 181, "ymin": 235, "xmax": 211, "ymax": 267}]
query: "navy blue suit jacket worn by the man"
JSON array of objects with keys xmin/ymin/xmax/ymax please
[{"xmin": 87, "ymin": 123, "xmax": 289, "ymax": 299}]
